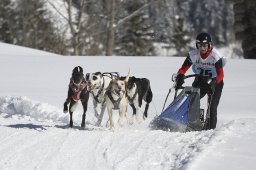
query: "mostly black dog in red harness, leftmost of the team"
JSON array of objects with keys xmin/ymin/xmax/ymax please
[{"xmin": 63, "ymin": 66, "xmax": 89, "ymax": 128}]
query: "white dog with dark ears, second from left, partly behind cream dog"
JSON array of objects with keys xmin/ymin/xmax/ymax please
[{"xmin": 86, "ymin": 72, "xmax": 118, "ymax": 126}]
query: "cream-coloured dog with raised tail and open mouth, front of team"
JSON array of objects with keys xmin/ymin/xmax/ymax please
[{"xmin": 105, "ymin": 71, "xmax": 130, "ymax": 129}]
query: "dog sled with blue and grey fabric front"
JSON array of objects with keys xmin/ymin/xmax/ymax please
[{"xmin": 149, "ymin": 74, "xmax": 211, "ymax": 132}]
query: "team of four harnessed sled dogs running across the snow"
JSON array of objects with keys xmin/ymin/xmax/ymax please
[{"xmin": 63, "ymin": 66, "xmax": 153, "ymax": 129}]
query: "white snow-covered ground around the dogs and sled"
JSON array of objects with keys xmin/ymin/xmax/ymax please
[{"xmin": 0, "ymin": 43, "xmax": 256, "ymax": 170}]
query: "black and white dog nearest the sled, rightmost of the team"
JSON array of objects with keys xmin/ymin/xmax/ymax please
[{"xmin": 127, "ymin": 76, "xmax": 153, "ymax": 123}]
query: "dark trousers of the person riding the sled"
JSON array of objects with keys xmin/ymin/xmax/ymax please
[{"xmin": 192, "ymin": 79, "xmax": 224, "ymax": 129}]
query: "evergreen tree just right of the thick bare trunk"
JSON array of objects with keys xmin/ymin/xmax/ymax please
[{"xmin": 116, "ymin": 0, "xmax": 155, "ymax": 56}]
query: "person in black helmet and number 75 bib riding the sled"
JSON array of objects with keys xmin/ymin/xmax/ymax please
[{"xmin": 175, "ymin": 32, "xmax": 226, "ymax": 130}]
